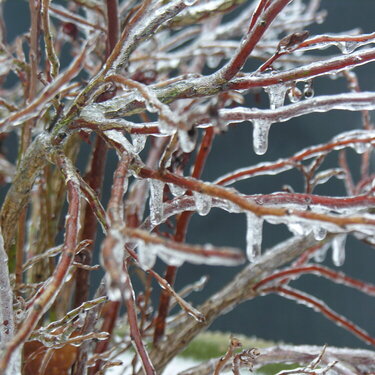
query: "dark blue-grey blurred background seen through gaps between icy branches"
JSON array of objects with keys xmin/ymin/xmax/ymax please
[{"xmin": 4, "ymin": 0, "xmax": 375, "ymax": 347}]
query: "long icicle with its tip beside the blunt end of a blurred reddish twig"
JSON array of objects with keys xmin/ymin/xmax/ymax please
[{"xmin": 246, "ymin": 212, "xmax": 263, "ymax": 262}]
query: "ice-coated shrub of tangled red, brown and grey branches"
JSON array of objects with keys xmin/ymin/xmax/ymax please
[{"xmin": 0, "ymin": 0, "xmax": 375, "ymax": 375}]
